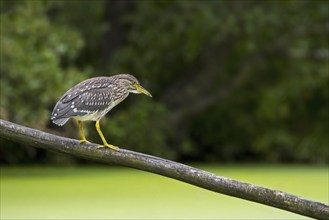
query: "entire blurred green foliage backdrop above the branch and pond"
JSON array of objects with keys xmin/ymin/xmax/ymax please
[{"xmin": 0, "ymin": 0, "xmax": 329, "ymax": 163}]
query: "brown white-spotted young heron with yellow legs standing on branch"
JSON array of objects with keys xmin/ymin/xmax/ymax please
[{"xmin": 51, "ymin": 74, "xmax": 152, "ymax": 150}]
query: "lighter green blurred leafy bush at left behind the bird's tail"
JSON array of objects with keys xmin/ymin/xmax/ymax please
[{"xmin": 1, "ymin": 0, "xmax": 84, "ymax": 127}]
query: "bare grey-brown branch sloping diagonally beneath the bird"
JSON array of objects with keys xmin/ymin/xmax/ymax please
[{"xmin": 0, "ymin": 119, "xmax": 329, "ymax": 219}]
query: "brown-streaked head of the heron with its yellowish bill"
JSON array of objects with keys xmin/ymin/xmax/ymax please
[{"xmin": 118, "ymin": 74, "xmax": 152, "ymax": 97}]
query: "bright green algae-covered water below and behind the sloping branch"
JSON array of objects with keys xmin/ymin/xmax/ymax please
[{"xmin": 0, "ymin": 164, "xmax": 329, "ymax": 219}]
